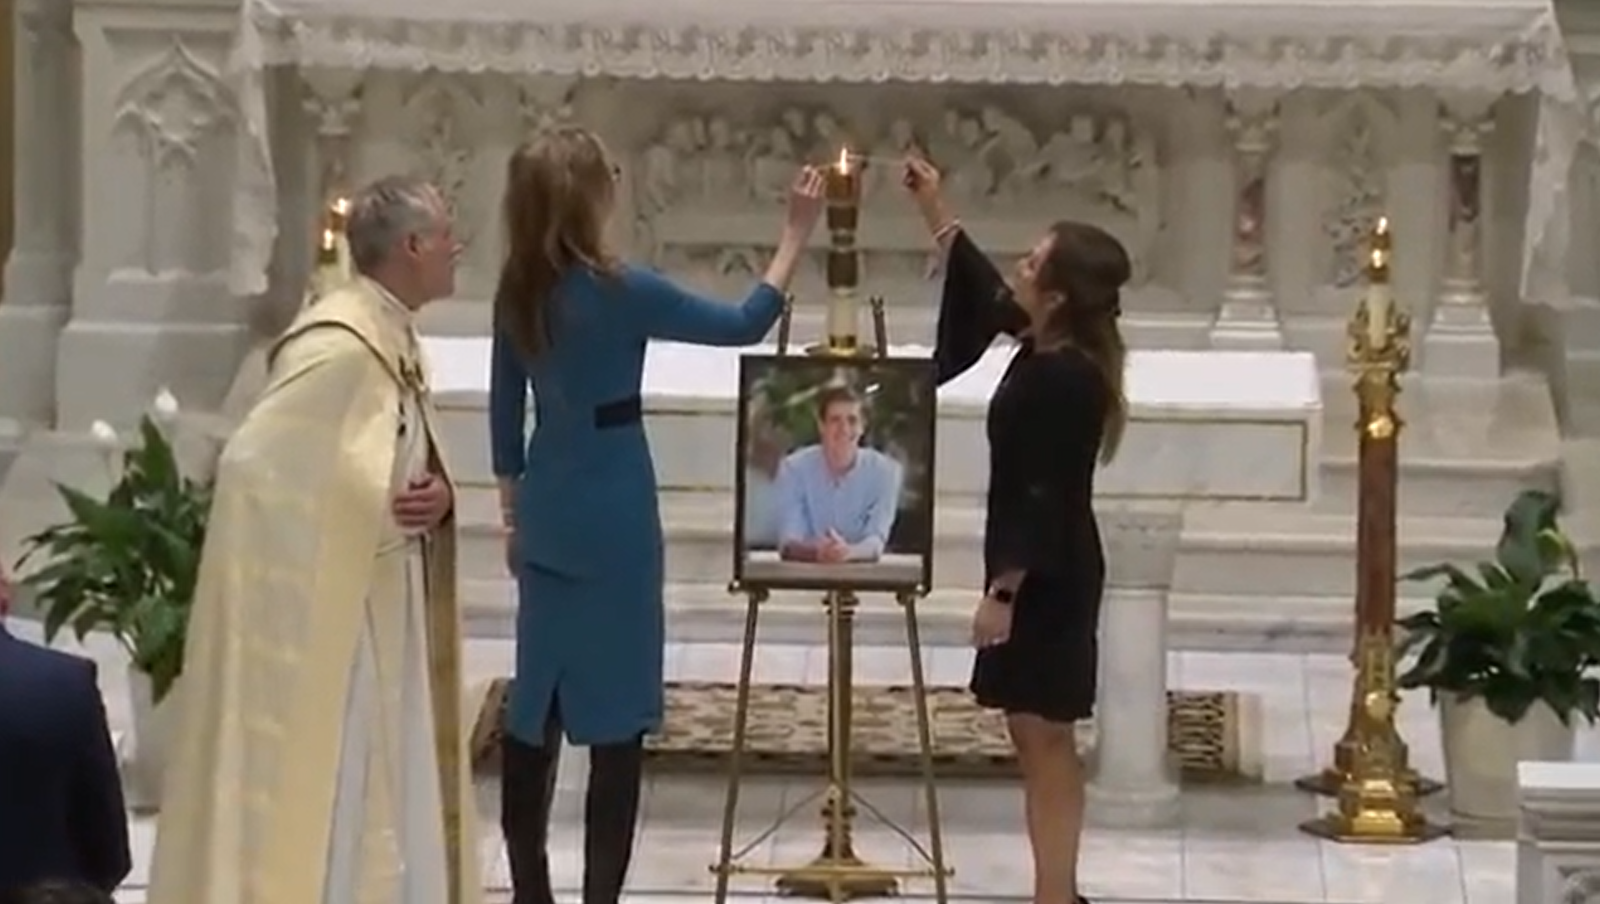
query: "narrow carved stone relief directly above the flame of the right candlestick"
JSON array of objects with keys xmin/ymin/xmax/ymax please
[{"xmin": 1322, "ymin": 93, "xmax": 1394, "ymax": 288}]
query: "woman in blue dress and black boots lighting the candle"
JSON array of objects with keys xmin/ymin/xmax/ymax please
[{"xmin": 490, "ymin": 128, "xmax": 822, "ymax": 904}]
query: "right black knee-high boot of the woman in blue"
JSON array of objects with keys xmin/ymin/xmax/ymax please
[{"xmin": 584, "ymin": 738, "xmax": 645, "ymax": 904}]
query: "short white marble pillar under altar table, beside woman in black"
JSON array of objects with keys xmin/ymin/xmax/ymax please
[{"xmin": 1088, "ymin": 587, "xmax": 1179, "ymax": 829}]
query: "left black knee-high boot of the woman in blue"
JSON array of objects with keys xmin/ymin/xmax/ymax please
[{"xmin": 501, "ymin": 712, "xmax": 562, "ymax": 904}]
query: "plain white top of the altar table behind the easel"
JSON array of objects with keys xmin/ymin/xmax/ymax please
[{"xmin": 422, "ymin": 336, "xmax": 1322, "ymax": 419}]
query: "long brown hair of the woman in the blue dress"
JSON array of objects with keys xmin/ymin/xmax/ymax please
[{"xmin": 494, "ymin": 126, "xmax": 616, "ymax": 358}]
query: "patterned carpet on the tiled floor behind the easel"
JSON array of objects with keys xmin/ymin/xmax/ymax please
[{"xmin": 472, "ymin": 678, "xmax": 1259, "ymax": 782}]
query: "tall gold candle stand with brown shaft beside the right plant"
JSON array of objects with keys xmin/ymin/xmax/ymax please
[{"xmin": 1296, "ymin": 218, "xmax": 1445, "ymax": 845}]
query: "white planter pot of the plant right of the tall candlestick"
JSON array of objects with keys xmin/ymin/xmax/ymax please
[{"xmin": 1438, "ymin": 694, "xmax": 1573, "ymax": 826}]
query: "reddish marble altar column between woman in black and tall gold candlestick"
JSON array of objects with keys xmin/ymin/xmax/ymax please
[{"xmin": 1211, "ymin": 91, "xmax": 1283, "ymax": 349}]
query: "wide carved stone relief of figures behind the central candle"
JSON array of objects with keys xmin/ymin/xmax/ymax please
[{"xmin": 632, "ymin": 104, "xmax": 1160, "ymax": 292}]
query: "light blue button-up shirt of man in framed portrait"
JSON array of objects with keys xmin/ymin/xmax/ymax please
[{"xmin": 776, "ymin": 446, "xmax": 904, "ymax": 562}]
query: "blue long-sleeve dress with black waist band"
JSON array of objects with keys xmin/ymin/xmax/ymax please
[{"xmin": 490, "ymin": 267, "xmax": 784, "ymax": 747}]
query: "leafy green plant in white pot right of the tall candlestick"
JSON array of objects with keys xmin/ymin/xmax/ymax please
[{"xmin": 1398, "ymin": 490, "xmax": 1600, "ymax": 824}]
